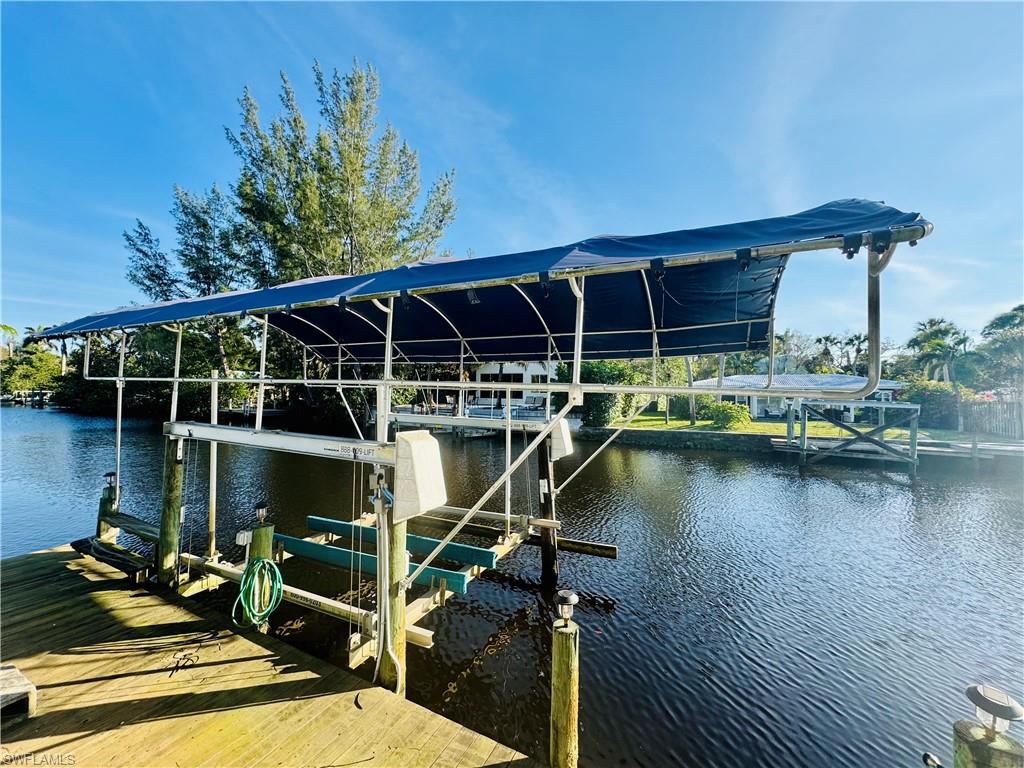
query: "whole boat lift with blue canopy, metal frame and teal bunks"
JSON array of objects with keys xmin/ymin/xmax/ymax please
[{"xmin": 39, "ymin": 201, "xmax": 932, "ymax": 691}]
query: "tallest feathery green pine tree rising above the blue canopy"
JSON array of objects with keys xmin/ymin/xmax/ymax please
[{"xmin": 227, "ymin": 58, "xmax": 456, "ymax": 286}]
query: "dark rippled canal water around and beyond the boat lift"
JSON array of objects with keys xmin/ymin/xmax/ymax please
[{"xmin": 0, "ymin": 409, "xmax": 1024, "ymax": 767}]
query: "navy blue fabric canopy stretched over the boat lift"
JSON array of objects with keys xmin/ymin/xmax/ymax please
[{"xmin": 34, "ymin": 200, "xmax": 931, "ymax": 362}]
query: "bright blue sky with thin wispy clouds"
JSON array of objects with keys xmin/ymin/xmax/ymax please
[{"xmin": 0, "ymin": 3, "xmax": 1024, "ymax": 341}]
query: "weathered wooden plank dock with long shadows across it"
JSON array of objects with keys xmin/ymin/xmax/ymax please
[{"xmin": 0, "ymin": 546, "xmax": 540, "ymax": 768}]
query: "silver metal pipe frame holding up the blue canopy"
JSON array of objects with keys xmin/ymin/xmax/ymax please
[{"xmin": 52, "ymin": 199, "xmax": 931, "ymax": 696}]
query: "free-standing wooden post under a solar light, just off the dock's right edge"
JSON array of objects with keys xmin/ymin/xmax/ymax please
[{"xmin": 548, "ymin": 618, "xmax": 580, "ymax": 768}]
